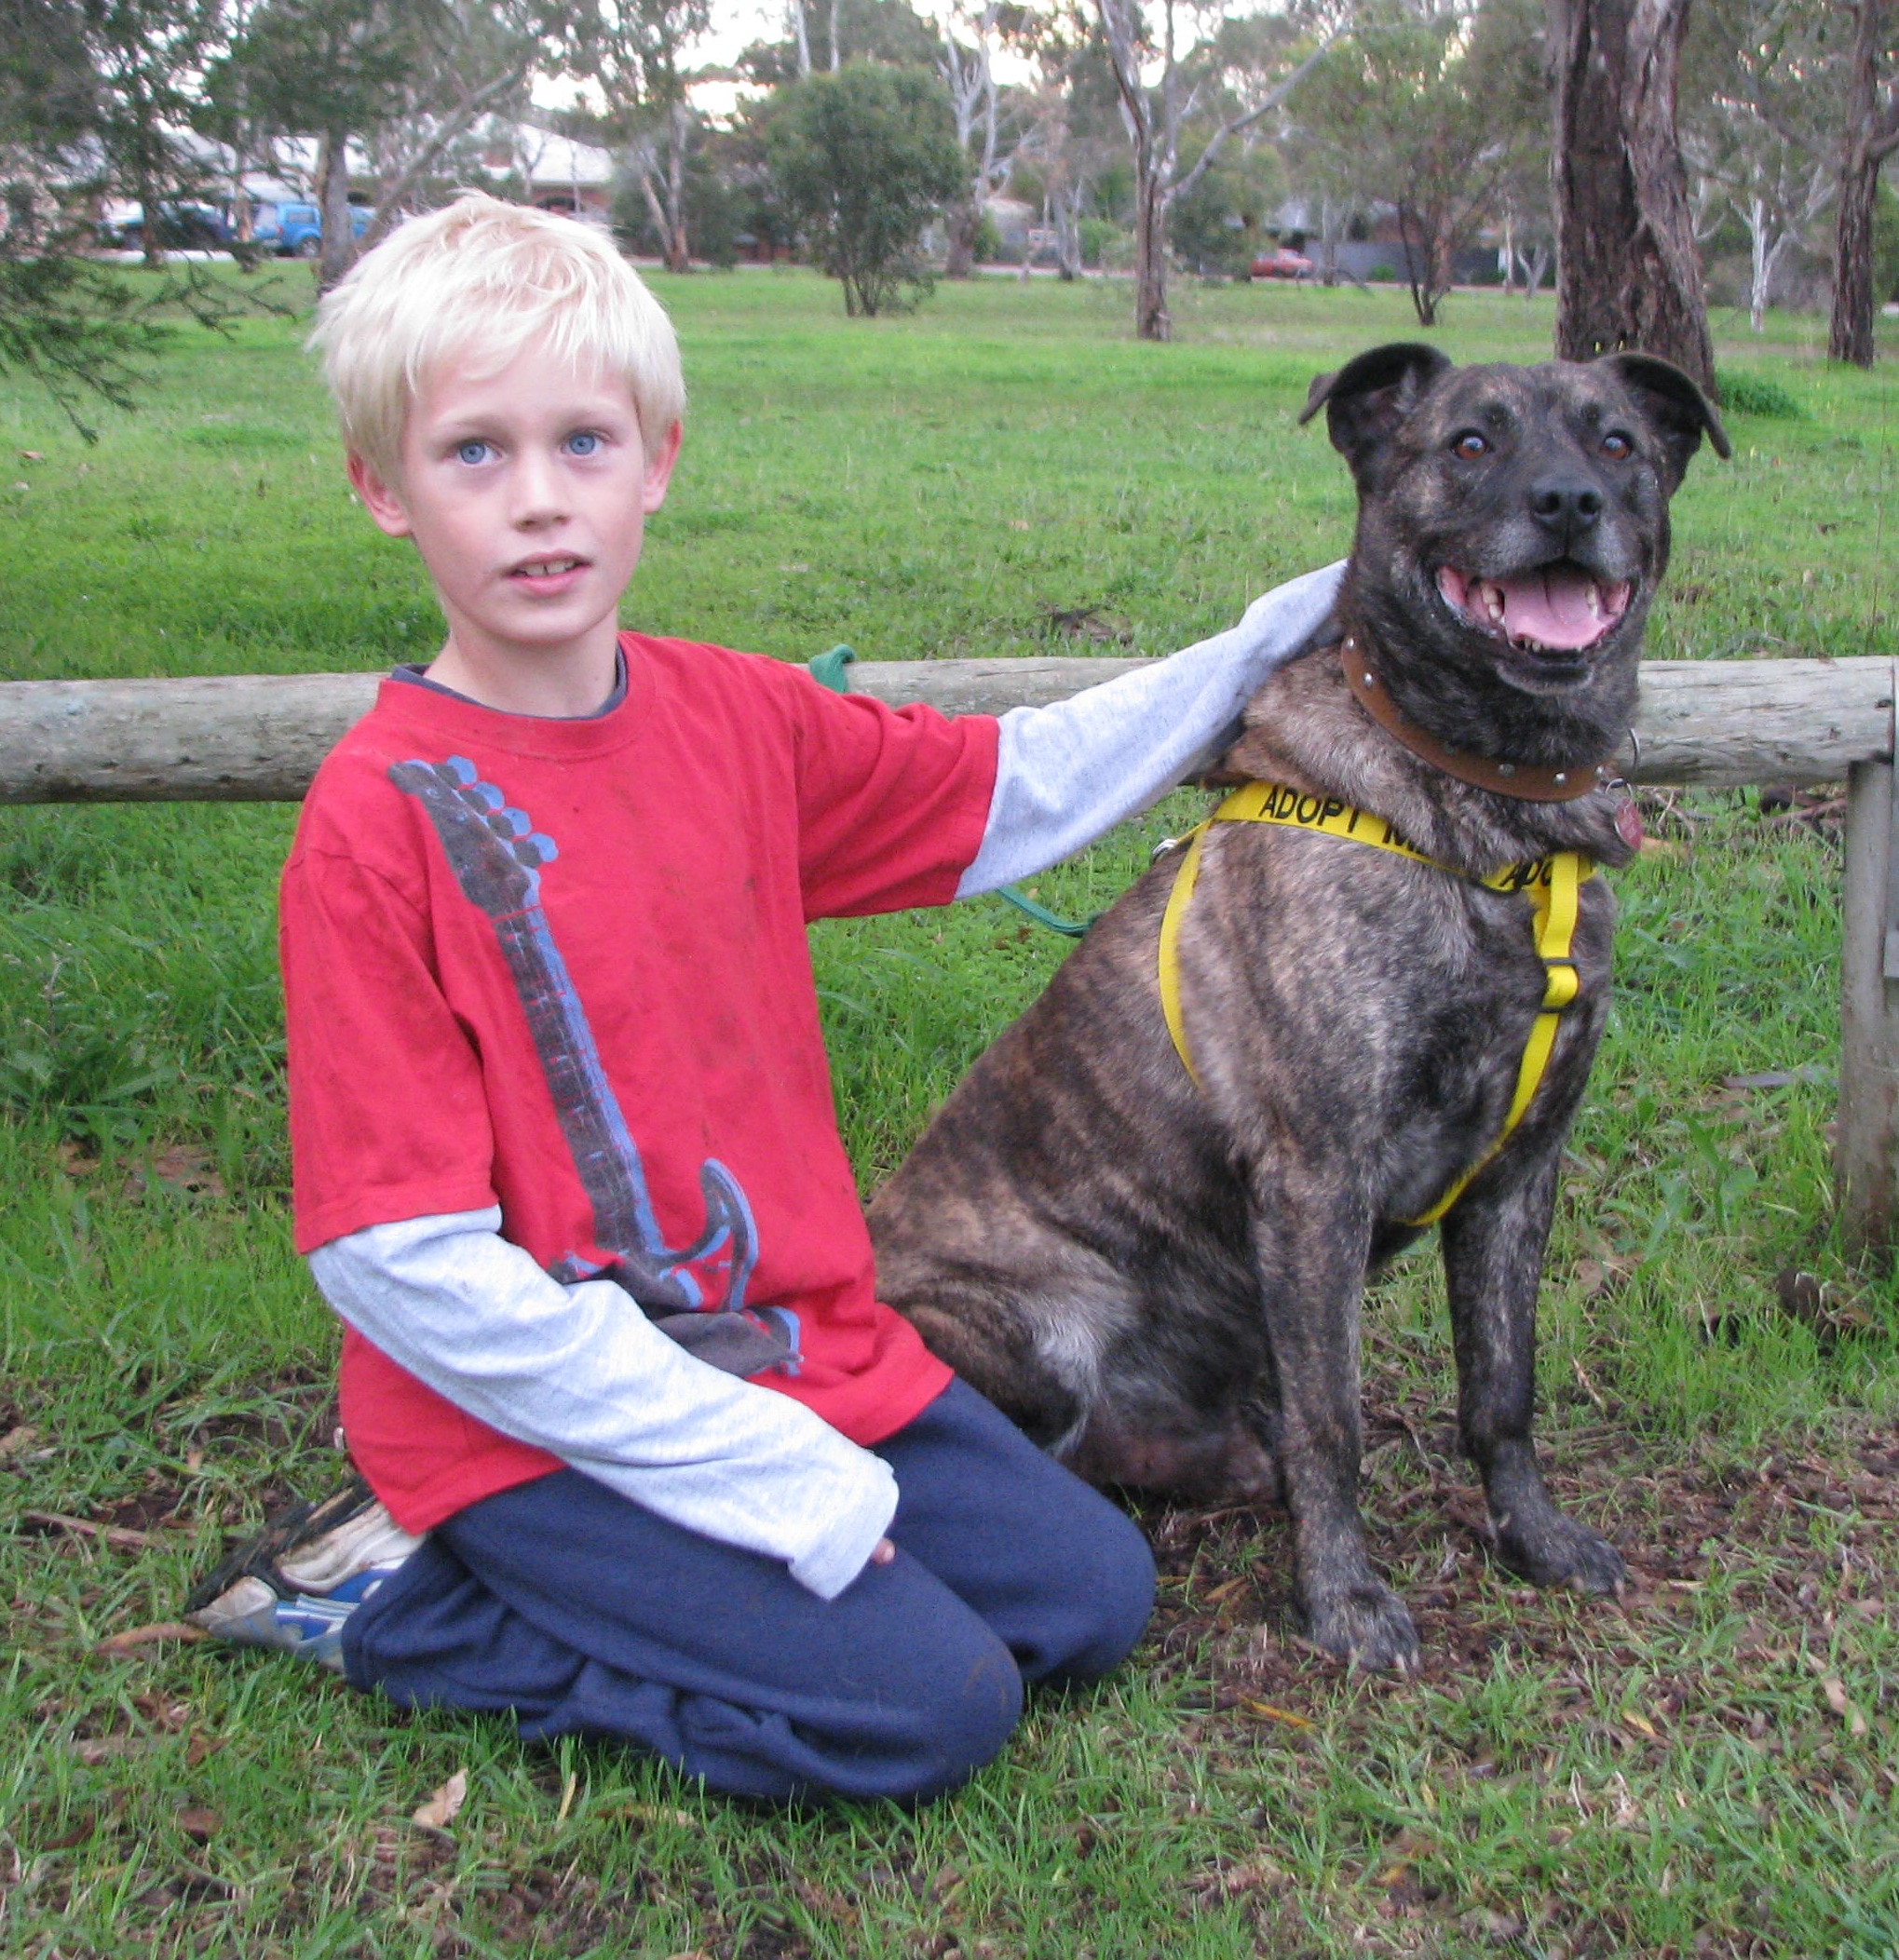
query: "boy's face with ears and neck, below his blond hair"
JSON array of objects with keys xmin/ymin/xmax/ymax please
[{"xmin": 349, "ymin": 343, "xmax": 680, "ymax": 697}]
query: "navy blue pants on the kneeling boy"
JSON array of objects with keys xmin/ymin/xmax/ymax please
[{"xmin": 343, "ymin": 1382, "xmax": 1154, "ymax": 1801}]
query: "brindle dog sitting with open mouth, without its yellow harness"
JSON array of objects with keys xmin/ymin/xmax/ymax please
[{"xmin": 870, "ymin": 345, "xmax": 1729, "ymax": 1666}]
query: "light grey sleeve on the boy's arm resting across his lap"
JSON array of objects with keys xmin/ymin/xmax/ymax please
[{"xmin": 309, "ymin": 1208, "xmax": 898, "ymax": 1600}]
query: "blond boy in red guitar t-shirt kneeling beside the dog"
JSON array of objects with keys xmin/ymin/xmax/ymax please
[{"xmin": 190, "ymin": 196, "xmax": 1336, "ymax": 1801}]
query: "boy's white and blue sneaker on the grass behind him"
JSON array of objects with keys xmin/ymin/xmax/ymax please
[{"xmin": 184, "ymin": 1476, "xmax": 421, "ymax": 1674}]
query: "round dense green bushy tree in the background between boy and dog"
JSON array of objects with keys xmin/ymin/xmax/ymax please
[{"xmin": 766, "ymin": 61, "xmax": 964, "ymax": 318}]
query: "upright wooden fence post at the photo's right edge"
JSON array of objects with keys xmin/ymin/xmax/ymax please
[{"xmin": 1832, "ymin": 761, "xmax": 1899, "ymax": 1256}]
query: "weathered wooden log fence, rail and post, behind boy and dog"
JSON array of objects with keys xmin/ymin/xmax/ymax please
[{"xmin": 0, "ymin": 658, "xmax": 1899, "ymax": 1252}]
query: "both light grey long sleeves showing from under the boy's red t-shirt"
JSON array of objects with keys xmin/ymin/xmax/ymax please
[{"xmin": 309, "ymin": 564, "xmax": 1342, "ymax": 1600}]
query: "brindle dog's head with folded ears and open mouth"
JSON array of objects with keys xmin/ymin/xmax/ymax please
[{"xmin": 1299, "ymin": 343, "xmax": 1729, "ymax": 711}]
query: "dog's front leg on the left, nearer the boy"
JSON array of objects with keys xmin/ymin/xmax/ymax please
[{"xmin": 1255, "ymin": 1178, "xmax": 1418, "ymax": 1668}]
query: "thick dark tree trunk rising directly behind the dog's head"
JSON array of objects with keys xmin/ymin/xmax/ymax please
[{"xmin": 1548, "ymin": 0, "xmax": 1715, "ymax": 388}]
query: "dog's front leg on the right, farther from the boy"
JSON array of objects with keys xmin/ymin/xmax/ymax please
[{"xmin": 1443, "ymin": 1135, "xmax": 1622, "ymax": 1593}]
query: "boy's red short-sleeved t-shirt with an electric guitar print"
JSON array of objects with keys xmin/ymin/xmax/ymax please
[{"xmin": 282, "ymin": 633, "xmax": 996, "ymax": 1531}]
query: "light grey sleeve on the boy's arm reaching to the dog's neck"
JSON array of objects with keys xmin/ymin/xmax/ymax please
[{"xmin": 956, "ymin": 564, "xmax": 1345, "ymax": 898}]
